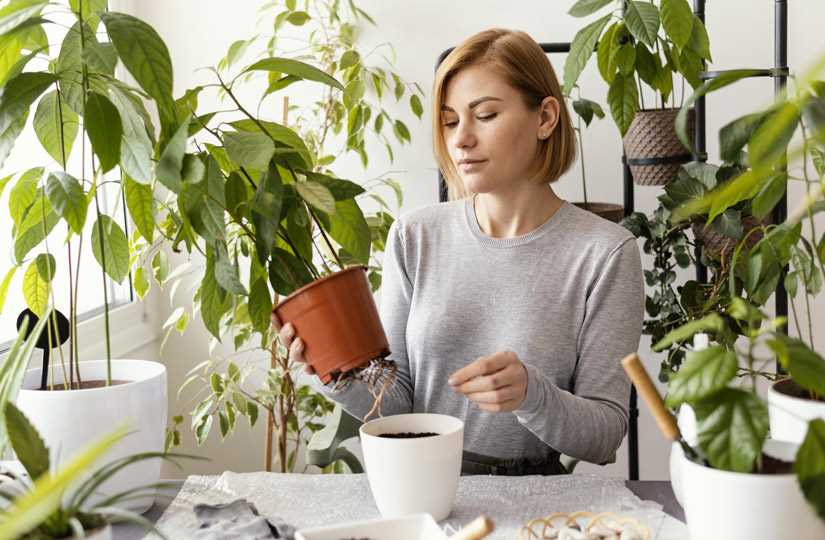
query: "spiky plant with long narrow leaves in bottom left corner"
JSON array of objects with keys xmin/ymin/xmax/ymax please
[{"xmin": 0, "ymin": 310, "xmax": 191, "ymax": 540}]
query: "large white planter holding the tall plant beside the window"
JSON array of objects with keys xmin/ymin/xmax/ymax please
[{"xmin": 17, "ymin": 360, "xmax": 167, "ymax": 512}]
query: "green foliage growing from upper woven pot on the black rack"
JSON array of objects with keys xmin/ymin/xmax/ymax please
[{"xmin": 564, "ymin": 0, "xmax": 711, "ymax": 135}]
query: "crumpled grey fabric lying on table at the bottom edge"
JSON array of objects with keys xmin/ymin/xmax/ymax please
[{"xmin": 193, "ymin": 499, "xmax": 295, "ymax": 540}]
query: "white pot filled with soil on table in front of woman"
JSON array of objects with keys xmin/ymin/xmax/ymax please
[{"xmin": 360, "ymin": 413, "xmax": 464, "ymax": 521}]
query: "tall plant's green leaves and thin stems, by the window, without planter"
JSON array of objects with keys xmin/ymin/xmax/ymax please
[{"xmin": 0, "ymin": 0, "xmax": 178, "ymax": 388}]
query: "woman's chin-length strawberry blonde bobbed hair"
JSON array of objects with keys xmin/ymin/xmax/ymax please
[{"xmin": 432, "ymin": 28, "xmax": 576, "ymax": 200}]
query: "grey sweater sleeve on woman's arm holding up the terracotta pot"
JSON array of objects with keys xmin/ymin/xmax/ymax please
[{"xmin": 312, "ymin": 221, "xmax": 413, "ymax": 420}]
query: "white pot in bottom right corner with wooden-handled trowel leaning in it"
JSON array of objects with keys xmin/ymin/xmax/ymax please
[{"xmin": 679, "ymin": 440, "xmax": 825, "ymax": 540}]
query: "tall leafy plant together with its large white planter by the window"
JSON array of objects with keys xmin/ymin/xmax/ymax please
[{"xmin": 0, "ymin": 0, "xmax": 176, "ymax": 509}]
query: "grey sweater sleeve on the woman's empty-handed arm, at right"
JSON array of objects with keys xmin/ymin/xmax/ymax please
[{"xmin": 513, "ymin": 237, "xmax": 644, "ymax": 464}]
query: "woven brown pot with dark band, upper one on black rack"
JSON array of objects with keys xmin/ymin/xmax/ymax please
[{"xmin": 622, "ymin": 109, "xmax": 695, "ymax": 186}]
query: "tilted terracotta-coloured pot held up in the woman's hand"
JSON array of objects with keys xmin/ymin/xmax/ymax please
[{"xmin": 274, "ymin": 266, "xmax": 390, "ymax": 384}]
